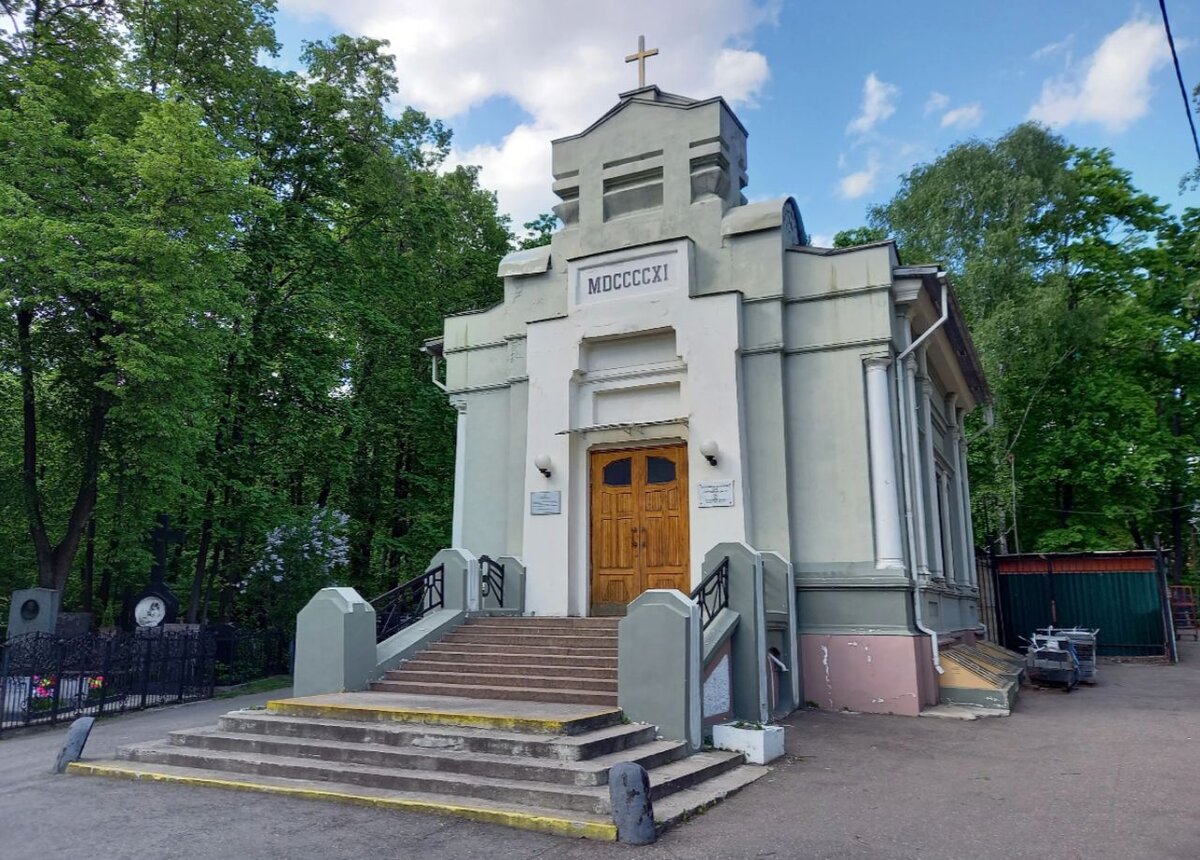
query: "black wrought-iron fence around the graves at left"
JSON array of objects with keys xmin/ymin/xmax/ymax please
[{"xmin": 0, "ymin": 629, "xmax": 289, "ymax": 735}]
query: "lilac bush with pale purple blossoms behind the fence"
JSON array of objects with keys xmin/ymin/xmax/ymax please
[{"xmin": 238, "ymin": 507, "xmax": 350, "ymax": 630}]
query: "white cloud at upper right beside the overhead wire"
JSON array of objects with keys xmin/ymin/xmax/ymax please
[{"xmin": 1030, "ymin": 19, "xmax": 1171, "ymax": 132}]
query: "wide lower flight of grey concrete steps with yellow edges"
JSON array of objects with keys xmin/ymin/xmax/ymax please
[{"xmin": 70, "ymin": 692, "xmax": 767, "ymax": 840}]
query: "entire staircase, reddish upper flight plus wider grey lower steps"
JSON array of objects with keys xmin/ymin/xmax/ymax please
[{"xmin": 70, "ymin": 618, "xmax": 768, "ymax": 840}]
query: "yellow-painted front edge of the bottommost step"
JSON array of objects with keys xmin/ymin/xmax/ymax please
[{"xmin": 67, "ymin": 762, "xmax": 617, "ymax": 842}]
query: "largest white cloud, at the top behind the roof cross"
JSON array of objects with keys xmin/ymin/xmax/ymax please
[{"xmin": 280, "ymin": 0, "xmax": 780, "ymax": 224}]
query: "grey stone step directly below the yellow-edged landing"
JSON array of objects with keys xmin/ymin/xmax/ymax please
[{"xmin": 217, "ymin": 710, "xmax": 655, "ymax": 762}]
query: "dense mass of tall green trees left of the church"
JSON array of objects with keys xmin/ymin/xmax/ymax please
[{"xmin": 0, "ymin": 0, "xmax": 511, "ymax": 624}]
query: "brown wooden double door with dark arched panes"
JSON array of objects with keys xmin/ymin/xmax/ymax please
[{"xmin": 590, "ymin": 445, "xmax": 691, "ymax": 615}]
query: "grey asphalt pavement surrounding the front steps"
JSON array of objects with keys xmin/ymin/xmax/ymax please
[{"xmin": 0, "ymin": 642, "xmax": 1200, "ymax": 860}]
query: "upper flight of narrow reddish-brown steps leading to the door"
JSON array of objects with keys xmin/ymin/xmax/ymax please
[{"xmin": 371, "ymin": 618, "xmax": 620, "ymax": 708}]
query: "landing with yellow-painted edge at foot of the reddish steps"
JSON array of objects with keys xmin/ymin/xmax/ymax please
[{"xmin": 266, "ymin": 681, "xmax": 624, "ymax": 735}]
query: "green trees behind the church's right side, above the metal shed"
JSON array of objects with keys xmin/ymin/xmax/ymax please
[{"xmin": 870, "ymin": 125, "xmax": 1200, "ymax": 563}]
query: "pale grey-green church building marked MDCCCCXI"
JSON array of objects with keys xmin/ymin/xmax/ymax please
[{"xmin": 426, "ymin": 80, "xmax": 989, "ymax": 715}]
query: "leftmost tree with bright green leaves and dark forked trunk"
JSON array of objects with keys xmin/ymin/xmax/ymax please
[{"xmin": 0, "ymin": 4, "xmax": 261, "ymax": 589}]
